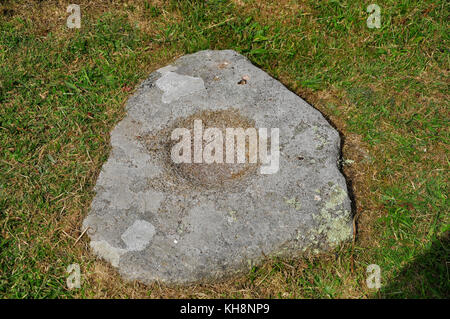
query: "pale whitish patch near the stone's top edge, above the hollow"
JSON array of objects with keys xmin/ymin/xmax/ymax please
[{"xmin": 156, "ymin": 71, "xmax": 206, "ymax": 103}]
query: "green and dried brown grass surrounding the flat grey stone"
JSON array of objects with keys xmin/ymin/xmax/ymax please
[{"xmin": 0, "ymin": 0, "xmax": 450, "ymax": 298}]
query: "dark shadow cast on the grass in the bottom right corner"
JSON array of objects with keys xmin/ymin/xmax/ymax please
[{"xmin": 381, "ymin": 232, "xmax": 450, "ymax": 299}]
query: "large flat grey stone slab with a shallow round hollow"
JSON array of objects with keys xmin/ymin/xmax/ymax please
[{"xmin": 83, "ymin": 50, "xmax": 353, "ymax": 284}]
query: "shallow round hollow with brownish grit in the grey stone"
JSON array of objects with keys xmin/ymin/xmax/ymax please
[{"xmin": 165, "ymin": 109, "xmax": 258, "ymax": 187}]
